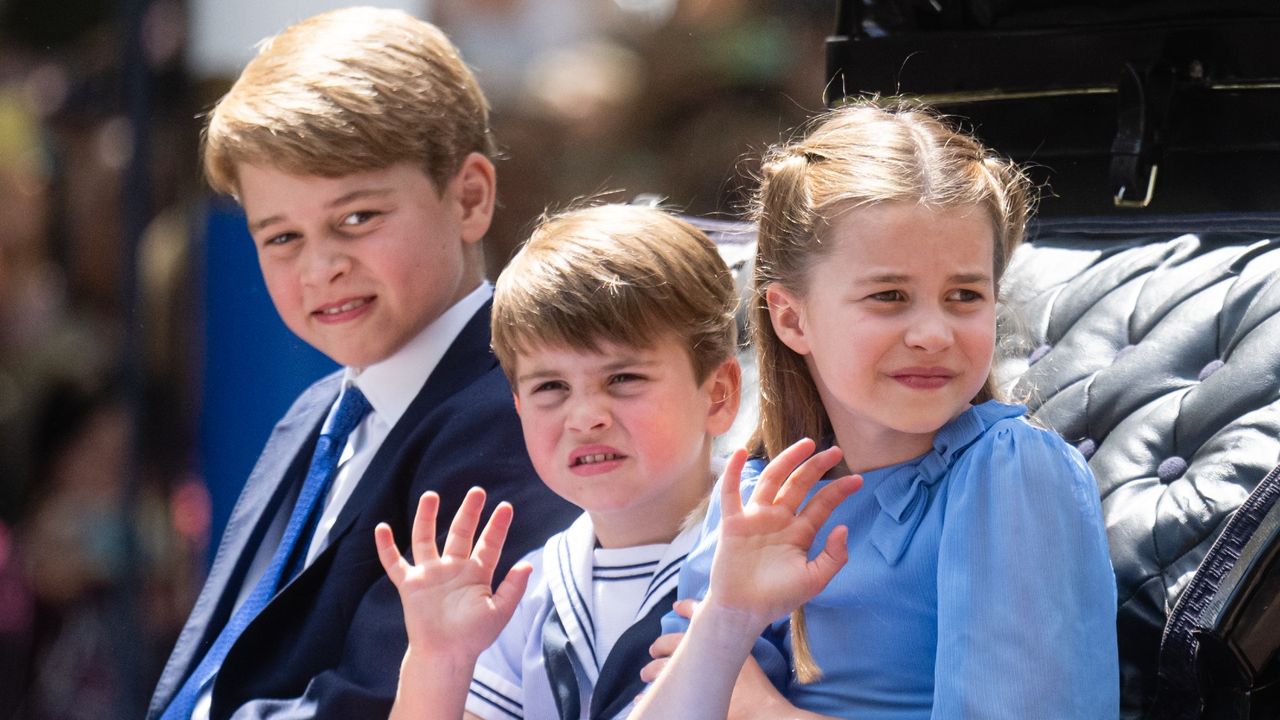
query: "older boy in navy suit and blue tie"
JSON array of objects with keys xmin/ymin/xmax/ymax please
[{"xmin": 147, "ymin": 8, "xmax": 572, "ymax": 720}]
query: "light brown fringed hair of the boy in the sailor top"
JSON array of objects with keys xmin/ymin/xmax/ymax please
[{"xmin": 492, "ymin": 205, "xmax": 737, "ymax": 386}]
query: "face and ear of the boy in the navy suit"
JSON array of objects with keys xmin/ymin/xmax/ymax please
[{"xmin": 237, "ymin": 154, "xmax": 494, "ymax": 368}]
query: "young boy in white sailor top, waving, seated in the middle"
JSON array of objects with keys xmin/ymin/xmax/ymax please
[{"xmin": 375, "ymin": 205, "xmax": 741, "ymax": 720}]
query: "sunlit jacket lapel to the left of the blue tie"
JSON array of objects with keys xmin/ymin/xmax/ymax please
[{"xmin": 148, "ymin": 373, "xmax": 342, "ymax": 715}]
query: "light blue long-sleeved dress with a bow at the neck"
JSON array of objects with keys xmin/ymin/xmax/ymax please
[{"xmin": 664, "ymin": 402, "xmax": 1120, "ymax": 720}]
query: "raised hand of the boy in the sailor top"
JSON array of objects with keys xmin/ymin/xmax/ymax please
[{"xmin": 374, "ymin": 488, "xmax": 532, "ymax": 662}]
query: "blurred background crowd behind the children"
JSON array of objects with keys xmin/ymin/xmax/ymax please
[{"xmin": 0, "ymin": 0, "xmax": 835, "ymax": 720}]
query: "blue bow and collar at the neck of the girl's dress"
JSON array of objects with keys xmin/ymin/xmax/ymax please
[{"xmin": 863, "ymin": 400, "xmax": 1027, "ymax": 565}]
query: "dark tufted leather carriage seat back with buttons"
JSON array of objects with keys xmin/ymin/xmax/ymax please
[{"xmin": 704, "ymin": 213, "xmax": 1280, "ymax": 719}]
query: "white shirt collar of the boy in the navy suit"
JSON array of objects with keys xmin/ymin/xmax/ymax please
[{"xmin": 342, "ymin": 281, "xmax": 493, "ymax": 427}]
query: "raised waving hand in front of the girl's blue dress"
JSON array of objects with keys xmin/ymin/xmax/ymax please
[{"xmin": 707, "ymin": 439, "xmax": 861, "ymax": 629}]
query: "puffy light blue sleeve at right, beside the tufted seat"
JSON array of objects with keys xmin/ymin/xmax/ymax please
[{"xmin": 933, "ymin": 419, "xmax": 1120, "ymax": 720}]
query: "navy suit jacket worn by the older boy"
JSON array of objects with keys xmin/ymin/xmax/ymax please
[{"xmin": 147, "ymin": 304, "xmax": 580, "ymax": 720}]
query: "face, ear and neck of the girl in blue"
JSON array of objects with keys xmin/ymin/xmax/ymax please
[{"xmin": 767, "ymin": 202, "xmax": 996, "ymax": 471}]
